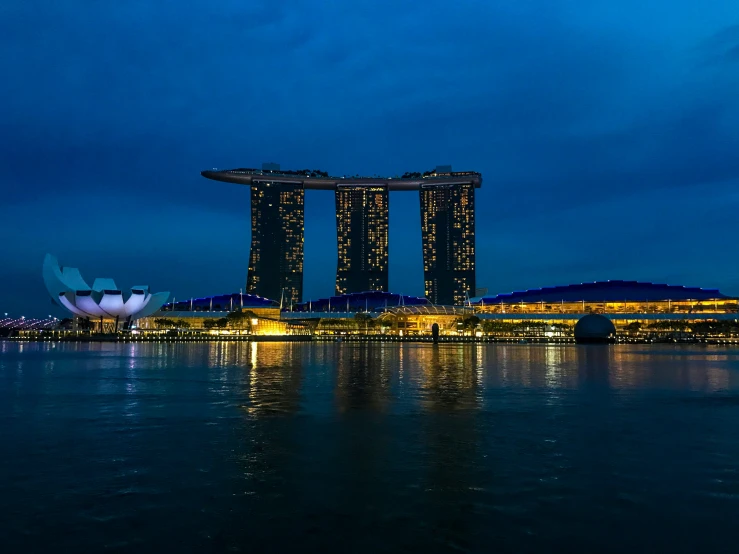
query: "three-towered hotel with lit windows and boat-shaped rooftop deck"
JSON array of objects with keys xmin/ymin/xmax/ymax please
[{"xmin": 202, "ymin": 164, "xmax": 482, "ymax": 305}]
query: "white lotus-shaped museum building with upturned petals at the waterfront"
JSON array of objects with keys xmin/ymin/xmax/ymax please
[{"xmin": 43, "ymin": 254, "xmax": 169, "ymax": 320}]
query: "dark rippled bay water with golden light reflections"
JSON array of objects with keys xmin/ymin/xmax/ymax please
[{"xmin": 0, "ymin": 342, "xmax": 739, "ymax": 552}]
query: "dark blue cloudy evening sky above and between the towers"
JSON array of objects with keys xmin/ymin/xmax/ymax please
[{"xmin": 0, "ymin": 0, "xmax": 739, "ymax": 315}]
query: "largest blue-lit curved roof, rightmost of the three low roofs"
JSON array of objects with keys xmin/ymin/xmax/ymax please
[{"xmin": 472, "ymin": 281, "xmax": 730, "ymax": 304}]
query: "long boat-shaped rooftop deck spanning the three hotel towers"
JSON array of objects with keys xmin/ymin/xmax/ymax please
[{"xmin": 201, "ymin": 168, "xmax": 482, "ymax": 191}]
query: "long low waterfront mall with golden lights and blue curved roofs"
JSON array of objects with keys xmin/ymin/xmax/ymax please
[{"xmin": 133, "ymin": 281, "xmax": 739, "ymax": 342}]
